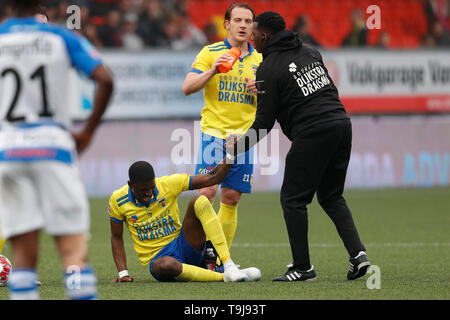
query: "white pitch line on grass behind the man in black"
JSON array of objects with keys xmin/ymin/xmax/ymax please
[{"xmin": 232, "ymin": 242, "xmax": 450, "ymax": 248}]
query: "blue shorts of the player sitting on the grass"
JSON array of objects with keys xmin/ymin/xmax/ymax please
[{"xmin": 149, "ymin": 228, "xmax": 206, "ymax": 281}]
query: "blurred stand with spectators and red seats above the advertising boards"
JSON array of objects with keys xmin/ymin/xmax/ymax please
[{"xmin": 0, "ymin": 0, "xmax": 450, "ymax": 50}]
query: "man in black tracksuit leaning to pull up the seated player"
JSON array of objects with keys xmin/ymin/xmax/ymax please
[{"xmin": 228, "ymin": 12, "xmax": 370, "ymax": 281}]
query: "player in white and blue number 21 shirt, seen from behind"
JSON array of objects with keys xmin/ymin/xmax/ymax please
[{"xmin": 0, "ymin": 0, "xmax": 113, "ymax": 299}]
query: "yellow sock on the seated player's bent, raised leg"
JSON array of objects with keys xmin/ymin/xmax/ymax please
[{"xmin": 194, "ymin": 196, "xmax": 230, "ymax": 262}]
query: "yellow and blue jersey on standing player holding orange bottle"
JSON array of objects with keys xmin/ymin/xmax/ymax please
[{"xmin": 191, "ymin": 38, "xmax": 262, "ymax": 139}]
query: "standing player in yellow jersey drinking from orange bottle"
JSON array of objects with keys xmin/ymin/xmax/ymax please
[{"xmin": 182, "ymin": 4, "xmax": 262, "ymax": 260}]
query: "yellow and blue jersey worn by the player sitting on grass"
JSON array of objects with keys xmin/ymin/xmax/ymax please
[{"xmin": 108, "ymin": 174, "xmax": 192, "ymax": 266}]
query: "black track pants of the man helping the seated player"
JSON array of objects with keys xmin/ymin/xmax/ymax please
[{"xmin": 280, "ymin": 120, "xmax": 365, "ymax": 267}]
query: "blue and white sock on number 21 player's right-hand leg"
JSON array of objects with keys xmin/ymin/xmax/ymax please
[{"xmin": 64, "ymin": 266, "xmax": 98, "ymax": 300}]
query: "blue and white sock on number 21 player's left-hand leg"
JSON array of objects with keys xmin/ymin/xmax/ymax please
[{"xmin": 8, "ymin": 268, "xmax": 39, "ymax": 300}]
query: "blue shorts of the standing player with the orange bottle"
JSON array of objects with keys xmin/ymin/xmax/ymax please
[{"xmin": 195, "ymin": 132, "xmax": 253, "ymax": 193}]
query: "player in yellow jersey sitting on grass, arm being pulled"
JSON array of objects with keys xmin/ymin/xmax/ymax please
[{"xmin": 108, "ymin": 161, "xmax": 261, "ymax": 282}]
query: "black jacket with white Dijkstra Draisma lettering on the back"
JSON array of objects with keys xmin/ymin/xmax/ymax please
[{"xmin": 235, "ymin": 30, "xmax": 349, "ymax": 152}]
